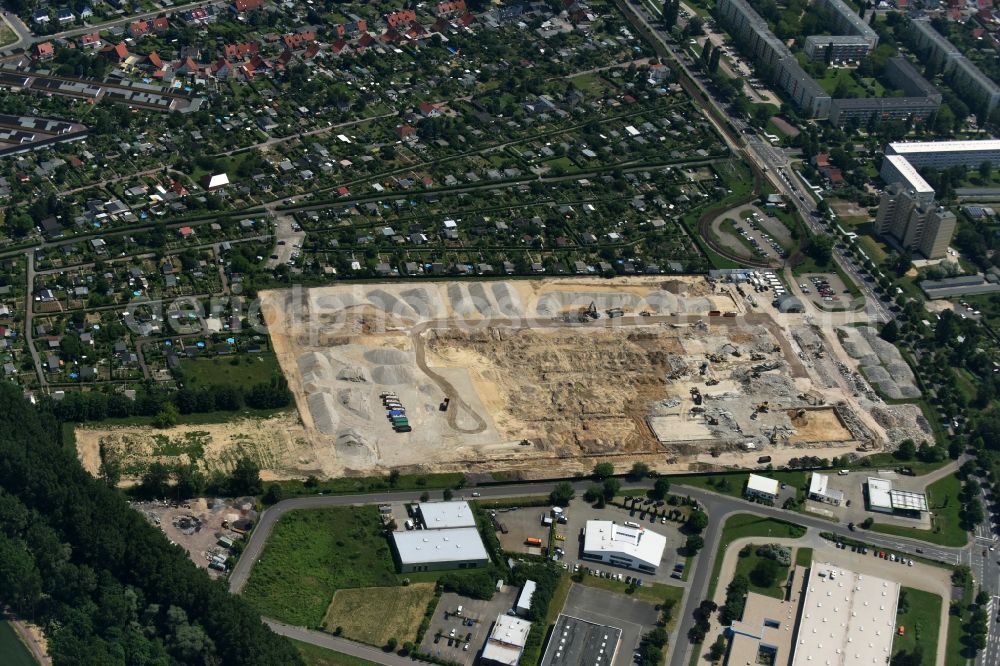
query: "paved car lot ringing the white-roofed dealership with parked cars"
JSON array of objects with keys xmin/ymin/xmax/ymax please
[{"xmin": 556, "ymin": 492, "xmax": 686, "ymax": 584}]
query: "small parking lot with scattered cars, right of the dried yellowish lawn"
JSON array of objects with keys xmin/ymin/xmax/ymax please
[{"xmin": 420, "ymin": 585, "xmax": 521, "ymax": 666}]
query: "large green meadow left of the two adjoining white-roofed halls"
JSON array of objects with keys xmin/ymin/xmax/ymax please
[{"xmin": 243, "ymin": 506, "xmax": 402, "ymax": 627}]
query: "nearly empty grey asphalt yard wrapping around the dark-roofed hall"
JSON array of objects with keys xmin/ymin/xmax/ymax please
[{"xmin": 562, "ymin": 583, "xmax": 659, "ymax": 666}]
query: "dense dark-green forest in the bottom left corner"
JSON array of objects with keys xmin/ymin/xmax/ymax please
[{"xmin": 0, "ymin": 385, "xmax": 302, "ymax": 666}]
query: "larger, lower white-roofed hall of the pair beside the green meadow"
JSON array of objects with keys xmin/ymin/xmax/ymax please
[{"xmin": 392, "ymin": 527, "xmax": 490, "ymax": 573}]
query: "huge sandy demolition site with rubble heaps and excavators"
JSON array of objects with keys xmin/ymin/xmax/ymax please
[{"xmin": 261, "ymin": 277, "xmax": 922, "ymax": 476}]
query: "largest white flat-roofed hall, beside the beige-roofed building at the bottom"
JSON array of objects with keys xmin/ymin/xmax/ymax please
[{"xmin": 792, "ymin": 562, "xmax": 899, "ymax": 666}]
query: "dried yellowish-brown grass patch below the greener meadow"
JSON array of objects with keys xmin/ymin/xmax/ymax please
[{"xmin": 323, "ymin": 583, "xmax": 435, "ymax": 647}]
